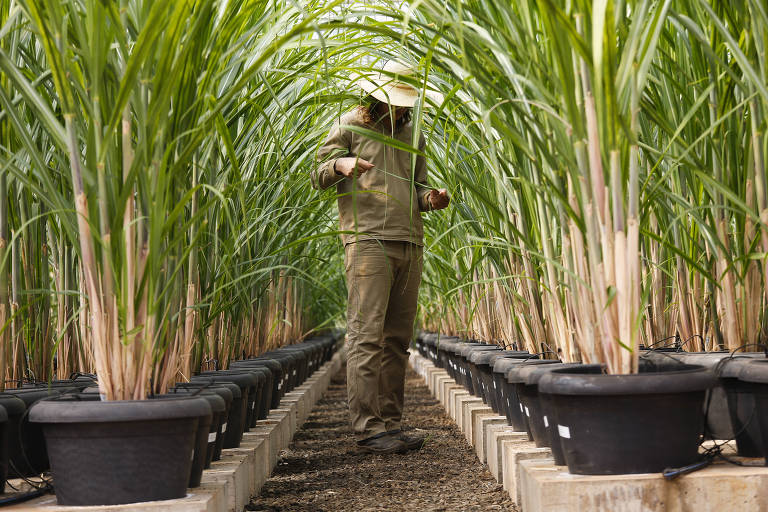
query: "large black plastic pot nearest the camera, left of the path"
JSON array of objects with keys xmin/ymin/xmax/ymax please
[{"xmin": 29, "ymin": 394, "xmax": 211, "ymax": 505}]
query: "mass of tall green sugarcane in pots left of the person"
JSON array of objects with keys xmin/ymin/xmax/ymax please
[{"xmin": 0, "ymin": 0, "xmax": 364, "ymax": 400}]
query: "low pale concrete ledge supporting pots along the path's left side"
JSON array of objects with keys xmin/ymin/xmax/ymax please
[{"xmin": 0, "ymin": 353, "xmax": 342, "ymax": 512}]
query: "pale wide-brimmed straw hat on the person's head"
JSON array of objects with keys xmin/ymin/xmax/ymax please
[{"xmin": 350, "ymin": 60, "xmax": 443, "ymax": 107}]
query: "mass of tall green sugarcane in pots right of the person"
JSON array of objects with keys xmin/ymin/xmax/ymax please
[{"xmin": 390, "ymin": 0, "xmax": 768, "ymax": 373}]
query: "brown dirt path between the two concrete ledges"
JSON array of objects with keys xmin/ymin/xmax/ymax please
[{"xmin": 246, "ymin": 364, "xmax": 516, "ymax": 512}]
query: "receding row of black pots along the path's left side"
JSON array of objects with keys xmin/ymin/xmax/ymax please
[{"xmin": 15, "ymin": 333, "xmax": 340, "ymax": 505}]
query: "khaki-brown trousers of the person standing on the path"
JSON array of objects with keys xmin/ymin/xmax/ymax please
[{"xmin": 345, "ymin": 240, "xmax": 422, "ymax": 439}]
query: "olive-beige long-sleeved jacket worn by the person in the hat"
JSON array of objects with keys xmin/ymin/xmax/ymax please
[{"xmin": 312, "ymin": 109, "xmax": 431, "ymax": 245}]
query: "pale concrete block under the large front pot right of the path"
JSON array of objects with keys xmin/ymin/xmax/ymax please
[{"xmin": 520, "ymin": 459, "xmax": 768, "ymax": 512}]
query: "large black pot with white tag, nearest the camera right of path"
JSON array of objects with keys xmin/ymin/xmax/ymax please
[{"xmin": 539, "ymin": 364, "xmax": 716, "ymax": 475}]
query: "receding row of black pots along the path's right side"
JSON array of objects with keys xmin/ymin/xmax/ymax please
[{"xmin": 416, "ymin": 333, "xmax": 768, "ymax": 474}]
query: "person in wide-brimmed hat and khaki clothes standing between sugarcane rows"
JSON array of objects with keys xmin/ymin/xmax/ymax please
[{"xmin": 312, "ymin": 61, "xmax": 450, "ymax": 453}]
